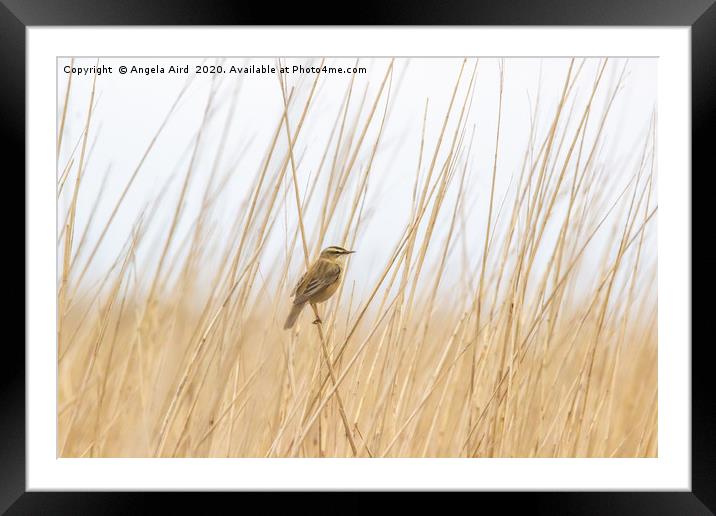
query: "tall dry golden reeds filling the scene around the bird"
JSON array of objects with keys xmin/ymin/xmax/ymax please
[{"xmin": 57, "ymin": 59, "xmax": 657, "ymax": 457}]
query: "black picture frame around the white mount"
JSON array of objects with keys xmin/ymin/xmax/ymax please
[{"xmin": 0, "ymin": 0, "xmax": 716, "ymax": 515}]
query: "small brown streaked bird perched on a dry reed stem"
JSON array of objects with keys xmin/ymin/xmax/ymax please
[{"xmin": 283, "ymin": 245, "xmax": 355, "ymax": 330}]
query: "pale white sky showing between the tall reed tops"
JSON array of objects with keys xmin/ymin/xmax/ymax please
[{"xmin": 57, "ymin": 58, "xmax": 657, "ymax": 298}]
